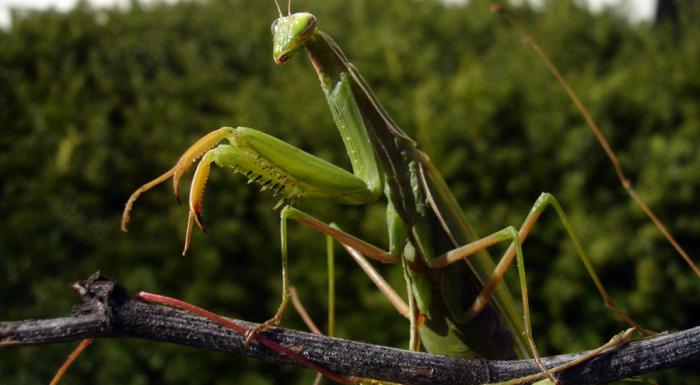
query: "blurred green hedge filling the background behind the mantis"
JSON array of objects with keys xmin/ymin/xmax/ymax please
[{"xmin": 0, "ymin": 0, "xmax": 700, "ymax": 384}]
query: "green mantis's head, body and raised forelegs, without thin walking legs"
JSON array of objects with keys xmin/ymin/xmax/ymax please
[{"xmin": 123, "ymin": 9, "xmax": 528, "ymax": 359}]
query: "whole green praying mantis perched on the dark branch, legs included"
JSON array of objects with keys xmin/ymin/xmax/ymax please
[{"xmin": 117, "ymin": 1, "xmax": 648, "ymax": 381}]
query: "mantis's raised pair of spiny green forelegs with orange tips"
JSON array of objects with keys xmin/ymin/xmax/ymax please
[{"xmin": 122, "ymin": 127, "xmax": 372, "ymax": 255}]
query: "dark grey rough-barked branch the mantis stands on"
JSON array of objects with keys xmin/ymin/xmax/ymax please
[{"xmin": 0, "ymin": 273, "xmax": 700, "ymax": 385}]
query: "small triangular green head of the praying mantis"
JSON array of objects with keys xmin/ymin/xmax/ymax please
[{"xmin": 272, "ymin": 12, "xmax": 316, "ymax": 64}]
